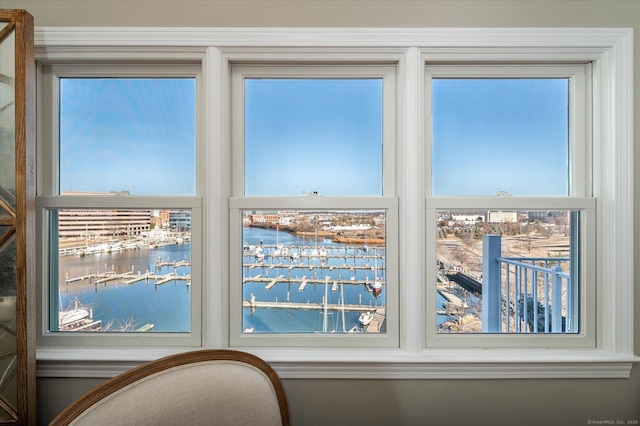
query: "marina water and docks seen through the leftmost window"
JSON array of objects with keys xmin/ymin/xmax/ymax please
[{"xmin": 58, "ymin": 240, "xmax": 192, "ymax": 333}]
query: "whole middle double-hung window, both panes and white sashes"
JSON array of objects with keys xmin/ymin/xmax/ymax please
[{"xmin": 229, "ymin": 63, "xmax": 399, "ymax": 347}]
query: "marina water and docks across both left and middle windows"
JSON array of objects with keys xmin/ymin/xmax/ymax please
[{"xmin": 58, "ymin": 227, "xmax": 386, "ymax": 333}]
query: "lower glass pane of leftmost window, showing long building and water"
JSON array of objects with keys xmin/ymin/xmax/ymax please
[{"xmin": 50, "ymin": 210, "xmax": 191, "ymax": 332}]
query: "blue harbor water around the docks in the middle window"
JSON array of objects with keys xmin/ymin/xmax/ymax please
[{"xmin": 242, "ymin": 227, "xmax": 386, "ymax": 333}]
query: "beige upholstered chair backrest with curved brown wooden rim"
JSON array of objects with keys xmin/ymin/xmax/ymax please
[{"xmin": 50, "ymin": 349, "xmax": 289, "ymax": 426}]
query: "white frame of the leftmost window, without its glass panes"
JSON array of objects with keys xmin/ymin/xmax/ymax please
[{"xmin": 36, "ymin": 61, "xmax": 203, "ymax": 348}]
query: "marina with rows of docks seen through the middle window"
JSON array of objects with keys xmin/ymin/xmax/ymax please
[{"xmin": 242, "ymin": 231, "xmax": 386, "ymax": 333}]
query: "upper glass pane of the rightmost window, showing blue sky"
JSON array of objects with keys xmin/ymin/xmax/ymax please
[{"xmin": 432, "ymin": 79, "xmax": 569, "ymax": 196}]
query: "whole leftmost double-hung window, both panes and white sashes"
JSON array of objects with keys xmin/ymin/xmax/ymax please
[{"xmin": 34, "ymin": 65, "xmax": 202, "ymax": 345}]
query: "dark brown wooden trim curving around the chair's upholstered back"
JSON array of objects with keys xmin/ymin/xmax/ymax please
[{"xmin": 49, "ymin": 349, "xmax": 290, "ymax": 426}]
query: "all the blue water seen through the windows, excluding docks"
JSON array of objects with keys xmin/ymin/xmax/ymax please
[{"xmin": 59, "ymin": 228, "xmax": 445, "ymax": 333}]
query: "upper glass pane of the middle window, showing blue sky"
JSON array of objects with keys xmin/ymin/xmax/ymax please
[{"xmin": 244, "ymin": 79, "xmax": 382, "ymax": 196}]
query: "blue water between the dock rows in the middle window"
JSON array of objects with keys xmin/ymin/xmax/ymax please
[{"xmin": 242, "ymin": 227, "xmax": 385, "ymax": 333}]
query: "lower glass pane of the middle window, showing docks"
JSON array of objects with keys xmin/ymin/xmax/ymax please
[{"xmin": 242, "ymin": 210, "xmax": 386, "ymax": 333}]
